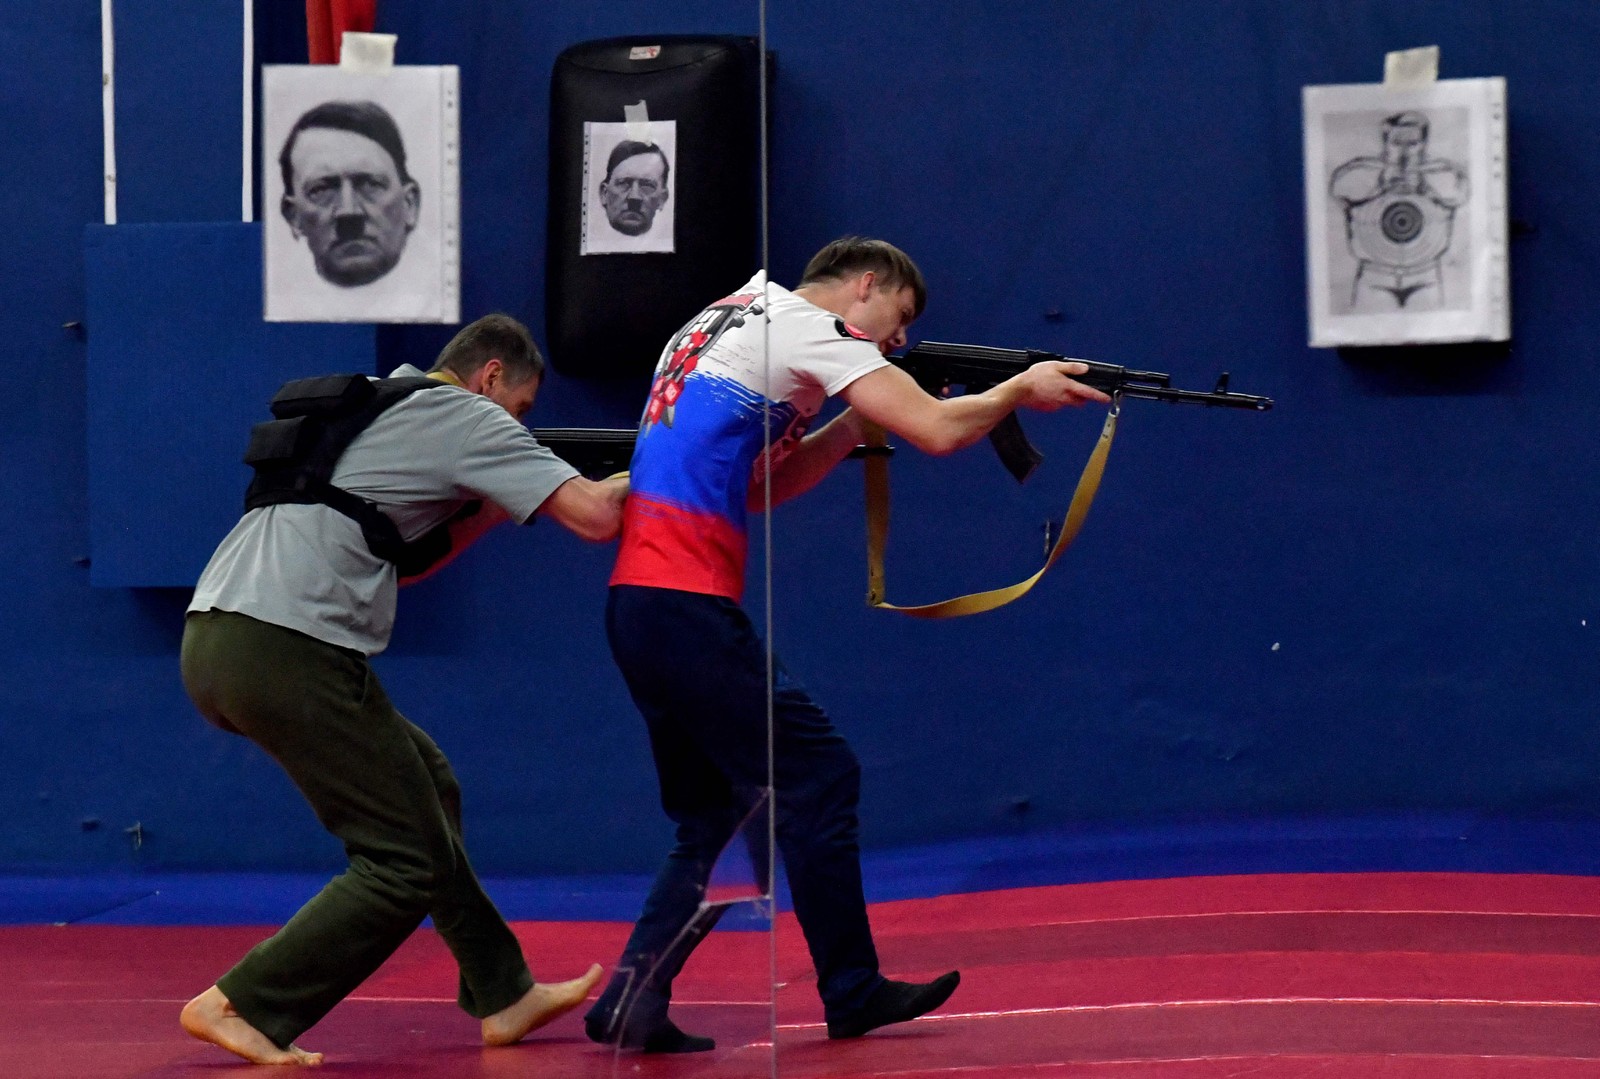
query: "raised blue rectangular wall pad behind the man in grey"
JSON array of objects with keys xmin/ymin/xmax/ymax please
[{"xmin": 83, "ymin": 224, "xmax": 374, "ymax": 588}]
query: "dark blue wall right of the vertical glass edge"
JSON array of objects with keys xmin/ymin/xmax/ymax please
[{"xmin": 752, "ymin": 0, "xmax": 1600, "ymax": 845}]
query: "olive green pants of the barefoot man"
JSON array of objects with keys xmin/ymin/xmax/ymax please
[{"xmin": 182, "ymin": 610, "xmax": 533, "ymax": 1047}]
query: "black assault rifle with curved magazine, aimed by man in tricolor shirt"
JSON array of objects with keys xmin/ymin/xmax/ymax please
[{"xmin": 888, "ymin": 341, "xmax": 1272, "ymax": 482}]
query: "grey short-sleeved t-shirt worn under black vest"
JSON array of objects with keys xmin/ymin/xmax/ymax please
[{"xmin": 189, "ymin": 365, "xmax": 578, "ymax": 655}]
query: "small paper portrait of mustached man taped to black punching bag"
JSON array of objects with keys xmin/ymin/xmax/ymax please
[{"xmin": 579, "ymin": 120, "xmax": 677, "ymax": 255}]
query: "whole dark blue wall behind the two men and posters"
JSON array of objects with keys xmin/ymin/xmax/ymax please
[{"xmin": 12, "ymin": 0, "xmax": 1600, "ymax": 872}]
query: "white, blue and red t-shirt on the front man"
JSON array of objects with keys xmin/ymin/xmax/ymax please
[{"xmin": 611, "ymin": 274, "xmax": 886, "ymax": 599}]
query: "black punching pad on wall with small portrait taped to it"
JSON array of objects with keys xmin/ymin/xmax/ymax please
[{"xmin": 546, "ymin": 35, "xmax": 762, "ymax": 378}]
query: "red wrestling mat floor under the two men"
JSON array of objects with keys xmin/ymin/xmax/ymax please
[{"xmin": 0, "ymin": 874, "xmax": 1600, "ymax": 1079}]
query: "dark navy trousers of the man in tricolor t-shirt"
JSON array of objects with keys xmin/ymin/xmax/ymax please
[{"xmin": 589, "ymin": 584, "xmax": 883, "ymax": 1031}]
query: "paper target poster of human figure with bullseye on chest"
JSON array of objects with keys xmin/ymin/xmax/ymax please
[{"xmin": 1302, "ymin": 78, "xmax": 1510, "ymax": 347}]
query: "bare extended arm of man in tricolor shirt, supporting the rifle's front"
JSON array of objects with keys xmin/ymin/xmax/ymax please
[{"xmin": 838, "ymin": 360, "xmax": 1110, "ymax": 456}]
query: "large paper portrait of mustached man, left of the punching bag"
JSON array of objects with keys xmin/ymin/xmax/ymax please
[{"xmin": 261, "ymin": 66, "xmax": 459, "ymax": 322}]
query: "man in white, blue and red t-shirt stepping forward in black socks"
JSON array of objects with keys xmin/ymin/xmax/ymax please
[{"xmin": 586, "ymin": 237, "xmax": 1109, "ymax": 1052}]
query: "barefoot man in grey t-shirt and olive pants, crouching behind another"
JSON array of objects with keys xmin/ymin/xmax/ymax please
[{"xmin": 181, "ymin": 315, "xmax": 627, "ymax": 1065}]
